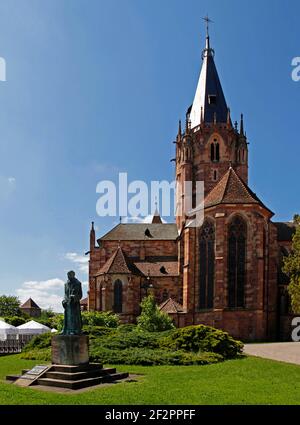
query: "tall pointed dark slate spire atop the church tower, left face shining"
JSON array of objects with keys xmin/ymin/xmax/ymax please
[{"xmin": 190, "ymin": 35, "xmax": 228, "ymax": 128}]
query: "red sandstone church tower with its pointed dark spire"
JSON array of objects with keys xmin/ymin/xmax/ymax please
[{"xmin": 176, "ymin": 24, "xmax": 248, "ymax": 228}]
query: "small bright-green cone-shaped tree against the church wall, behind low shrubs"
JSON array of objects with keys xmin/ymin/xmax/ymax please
[{"xmin": 137, "ymin": 295, "xmax": 174, "ymax": 332}]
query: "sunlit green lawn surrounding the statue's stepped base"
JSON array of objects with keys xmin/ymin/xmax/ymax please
[{"xmin": 0, "ymin": 355, "xmax": 300, "ymax": 405}]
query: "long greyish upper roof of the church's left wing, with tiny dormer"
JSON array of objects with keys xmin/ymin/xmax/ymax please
[{"xmin": 98, "ymin": 223, "xmax": 178, "ymax": 243}]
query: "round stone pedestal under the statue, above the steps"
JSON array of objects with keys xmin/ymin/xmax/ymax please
[{"xmin": 51, "ymin": 335, "xmax": 89, "ymax": 366}]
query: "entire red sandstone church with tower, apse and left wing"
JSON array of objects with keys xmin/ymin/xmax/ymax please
[{"xmin": 87, "ymin": 27, "xmax": 295, "ymax": 341}]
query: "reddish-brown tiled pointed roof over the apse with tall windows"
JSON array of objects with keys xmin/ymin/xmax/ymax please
[{"xmin": 204, "ymin": 167, "xmax": 271, "ymax": 212}]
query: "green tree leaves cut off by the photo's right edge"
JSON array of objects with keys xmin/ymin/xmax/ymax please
[{"xmin": 283, "ymin": 214, "xmax": 300, "ymax": 313}]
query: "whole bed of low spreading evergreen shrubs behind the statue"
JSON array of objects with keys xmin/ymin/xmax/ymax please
[{"xmin": 21, "ymin": 325, "xmax": 243, "ymax": 365}]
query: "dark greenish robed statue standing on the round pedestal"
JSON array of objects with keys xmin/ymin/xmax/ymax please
[{"xmin": 61, "ymin": 271, "xmax": 82, "ymax": 335}]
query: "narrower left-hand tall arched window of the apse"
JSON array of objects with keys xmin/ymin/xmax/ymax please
[{"xmin": 199, "ymin": 221, "xmax": 215, "ymax": 309}]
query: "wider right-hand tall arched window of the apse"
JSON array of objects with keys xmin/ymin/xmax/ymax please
[{"xmin": 228, "ymin": 217, "xmax": 247, "ymax": 308}]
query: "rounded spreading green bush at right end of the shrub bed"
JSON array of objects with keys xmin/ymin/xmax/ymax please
[{"xmin": 161, "ymin": 325, "xmax": 243, "ymax": 359}]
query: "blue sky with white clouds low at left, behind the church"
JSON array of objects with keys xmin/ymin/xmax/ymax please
[{"xmin": 0, "ymin": 0, "xmax": 300, "ymax": 309}]
